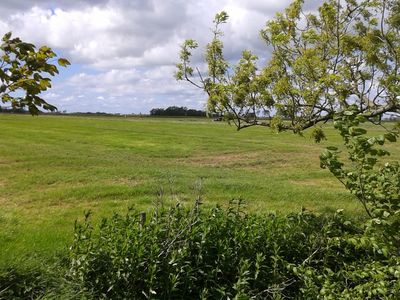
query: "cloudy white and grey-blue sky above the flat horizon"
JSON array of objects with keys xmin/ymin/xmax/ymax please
[{"xmin": 0, "ymin": 0, "xmax": 318, "ymax": 113}]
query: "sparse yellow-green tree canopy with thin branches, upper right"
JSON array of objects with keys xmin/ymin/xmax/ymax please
[{"xmin": 175, "ymin": 0, "xmax": 400, "ymax": 134}]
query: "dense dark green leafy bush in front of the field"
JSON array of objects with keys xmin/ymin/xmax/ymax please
[{"xmin": 70, "ymin": 206, "xmax": 400, "ymax": 299}]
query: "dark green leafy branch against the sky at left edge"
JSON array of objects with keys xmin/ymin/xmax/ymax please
[{"xmin": 0, "ymin": 32, "xmax": 70, "ymax": 115}]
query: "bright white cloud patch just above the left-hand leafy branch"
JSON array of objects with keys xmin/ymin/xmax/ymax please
[{"xmin": 9, "ymin": 7, "xmax": 120, "ymax": 62}]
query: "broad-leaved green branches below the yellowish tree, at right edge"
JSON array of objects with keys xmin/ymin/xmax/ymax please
[{"xmin": 320, "ymin": 106, "xmax": 400, "ymax": 251}]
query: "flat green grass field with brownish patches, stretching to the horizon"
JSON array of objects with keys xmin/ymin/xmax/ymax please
[{"xmin": 0, "ymin": 115, "xmax": 398, "ymax": 263}]
